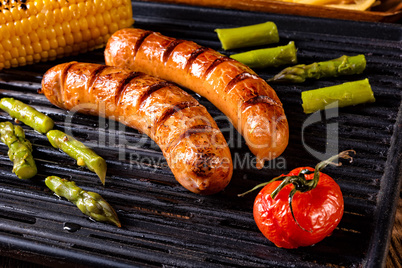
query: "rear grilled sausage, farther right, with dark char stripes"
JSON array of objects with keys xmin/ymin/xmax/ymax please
[{"xmin": 105, "ymin": 28, "xmax": 289, "ymax": 168}]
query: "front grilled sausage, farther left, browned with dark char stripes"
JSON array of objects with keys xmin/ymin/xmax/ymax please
[{"xmin": 41, "ymin": 62, "xmax": 233, "ymax": 194}]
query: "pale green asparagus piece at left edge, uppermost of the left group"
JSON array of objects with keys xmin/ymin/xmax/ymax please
[{"xmin": 0, "ymin": 98, "xmax": 54, "ymax": 133}]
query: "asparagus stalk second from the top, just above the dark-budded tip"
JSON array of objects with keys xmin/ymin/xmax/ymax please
[{"xmin": 230, "ymin": 41, "xmax": 297, "ymax": 68}]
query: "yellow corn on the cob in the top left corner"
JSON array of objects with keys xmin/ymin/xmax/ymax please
[{"xmin": 0, "ymin": 0, "xmax": 134, "ymax": 70}]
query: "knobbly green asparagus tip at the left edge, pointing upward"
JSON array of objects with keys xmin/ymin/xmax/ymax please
[{"xmin": 0, "ymin": 122, "xmax": 37, "ymax": 180}]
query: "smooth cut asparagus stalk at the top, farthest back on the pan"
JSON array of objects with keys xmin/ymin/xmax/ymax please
[{"xmin": 215, "ymin": 21, "xmax": 279, "ymax": 50}]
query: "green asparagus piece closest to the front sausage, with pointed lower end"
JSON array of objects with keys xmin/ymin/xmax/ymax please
[{"xmin": 46, "ymin": 130, "xmax": 107, "ymax": 185}]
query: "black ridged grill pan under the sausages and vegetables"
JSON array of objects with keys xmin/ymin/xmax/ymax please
[{"xmin": 0, "ymin": 1, "xmax": 402, "ymax": 267}]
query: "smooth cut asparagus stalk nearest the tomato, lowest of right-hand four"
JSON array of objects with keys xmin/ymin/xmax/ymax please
[{"xmin": 301, "ymin": 78, "xmax": 375, "ymax": 114}]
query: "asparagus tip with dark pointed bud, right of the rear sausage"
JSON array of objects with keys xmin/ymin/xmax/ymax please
[{"xmin": 267, "ymin": 55, "xmax": 366, "ymax": 83}]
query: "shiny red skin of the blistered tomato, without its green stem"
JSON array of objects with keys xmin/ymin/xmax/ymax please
[{"xmin": 253, "ymin": 167, "xmax": 344, "ymax": 249}]
